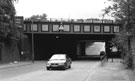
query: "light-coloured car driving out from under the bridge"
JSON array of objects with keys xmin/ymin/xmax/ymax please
[{"xmin": 46, "ymin": 54, "xmax": 72, "ymax": 70}]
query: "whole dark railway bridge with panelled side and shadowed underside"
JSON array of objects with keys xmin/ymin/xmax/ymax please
[{"xmin": 23, "ymin": 19, "xmax": 121, "ymax": 60}]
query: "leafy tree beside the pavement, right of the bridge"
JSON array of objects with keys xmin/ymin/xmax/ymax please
[{"xmin": 103, "ymin": 0, "xmax": 135, "ymax": 67}]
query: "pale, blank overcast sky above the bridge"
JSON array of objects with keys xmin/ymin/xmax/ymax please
[{"xmin": 15, "ymin": 0, "xmax": 112, "ymax": 19}]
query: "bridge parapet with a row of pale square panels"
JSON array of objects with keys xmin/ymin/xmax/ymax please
[{"xmin": 23, "ymin": 19, "xmax": 121, "ymax": 34}]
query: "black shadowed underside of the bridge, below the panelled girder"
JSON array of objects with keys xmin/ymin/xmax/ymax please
[{"xmin": 24, "ymin": 34, "xmax": 114, "ymax": 60}]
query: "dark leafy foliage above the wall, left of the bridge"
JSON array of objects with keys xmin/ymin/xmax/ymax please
[{"xmin": 0, "ymin": 0, "xmax": 21, "ymax": 45}]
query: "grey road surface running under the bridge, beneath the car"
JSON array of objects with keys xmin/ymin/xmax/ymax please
[{"xmin": 0, "ymin": 60, "xmax": 99, "ymax": 81}]
